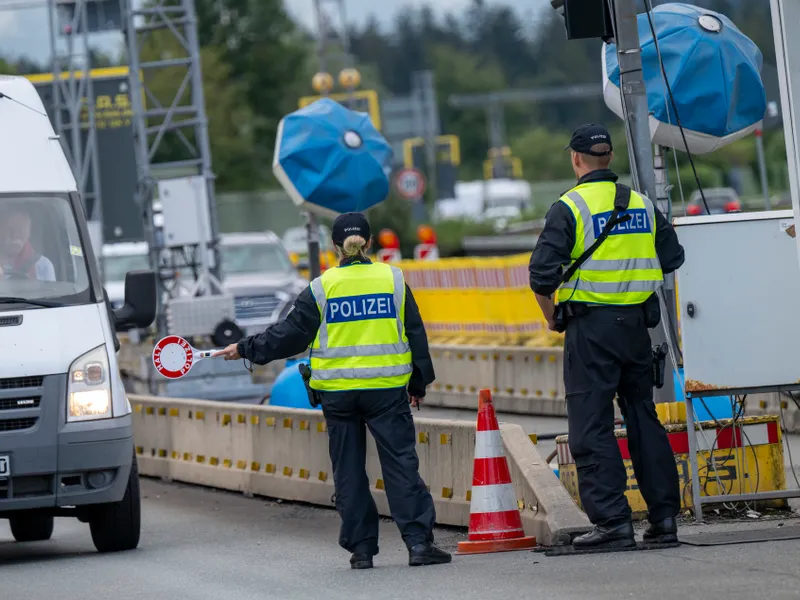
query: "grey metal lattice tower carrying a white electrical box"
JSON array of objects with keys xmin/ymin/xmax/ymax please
[{"xmin": 120, "ymin": 0, "xmax": 225, "ymax": 335}]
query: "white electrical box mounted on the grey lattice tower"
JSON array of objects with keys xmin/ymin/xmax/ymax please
[{"xmin": 158, "ymin": 176, "xmax": 211, "ymax": 248}]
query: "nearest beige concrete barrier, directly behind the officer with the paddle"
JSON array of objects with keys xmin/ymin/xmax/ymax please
[{"xmin": 130, "ymin": 396, "xmax": 589, "ymax": 545}]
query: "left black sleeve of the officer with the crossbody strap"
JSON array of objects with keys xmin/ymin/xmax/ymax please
[{"xmin": 528, "ymin": 201, "xmax": 575, "ymax": 296}]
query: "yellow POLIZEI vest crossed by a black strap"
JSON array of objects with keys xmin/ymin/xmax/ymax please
[{"xmin": 557, "ymin": 181, "xmax": 664, "ymax": 305}]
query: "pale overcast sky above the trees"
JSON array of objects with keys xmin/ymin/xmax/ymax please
[{"xmin": 0, "ymin": 0, "xmax": 549, "ymax": 67}]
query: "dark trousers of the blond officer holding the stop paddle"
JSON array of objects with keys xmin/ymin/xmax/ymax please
[{"xmin": 322, "ymin": 388, "xmax": 436, "ymax": 555}]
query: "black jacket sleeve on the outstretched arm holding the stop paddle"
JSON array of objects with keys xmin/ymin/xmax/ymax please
[{"xmin": 237, "ymin": 286, "xmax": 320, "ymax": 365}]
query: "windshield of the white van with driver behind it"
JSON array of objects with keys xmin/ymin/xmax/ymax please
[{"xmin": 0, "ymin": 194, "xmax": 92, "ymax": 310}]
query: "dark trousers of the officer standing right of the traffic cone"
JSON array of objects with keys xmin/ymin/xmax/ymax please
[{"xmin": 564, "ymin": 306, "xmax": 681, "ymax": 526}]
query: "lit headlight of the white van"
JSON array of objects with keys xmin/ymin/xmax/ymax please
[{"xmin": 67, "ymin": 345, "xmax": 113, "ymax": 422}]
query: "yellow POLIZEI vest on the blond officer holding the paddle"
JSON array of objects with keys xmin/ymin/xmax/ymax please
[{"xmin": 309, "ymin": 263, "xmax": 412, "ymax": 391}]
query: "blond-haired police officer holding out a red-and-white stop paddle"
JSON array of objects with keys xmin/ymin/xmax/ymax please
[{"xmin": 214, "ymin": 213, "xmax": 451, "ymax": 569}]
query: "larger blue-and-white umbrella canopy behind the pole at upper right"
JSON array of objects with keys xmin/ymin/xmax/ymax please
[{"xmin": 602, "ymin": 3, "xmax": 767, "ymax": 154}]
